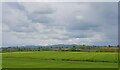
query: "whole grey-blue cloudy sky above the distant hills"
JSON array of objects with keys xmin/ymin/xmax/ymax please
[{"xmin": 2, "ymin": 2, "xmax": 118, "ymax": 46}]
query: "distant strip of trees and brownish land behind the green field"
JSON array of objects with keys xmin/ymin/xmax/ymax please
[{"xmin": 0, "ymin": 45, "xmax": 119, "ymax": 52}]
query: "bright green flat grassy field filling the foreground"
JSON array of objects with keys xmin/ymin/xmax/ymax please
[{"xmin": 2, "ymin": 51, "xmax": 118, "ymax": 68}]
